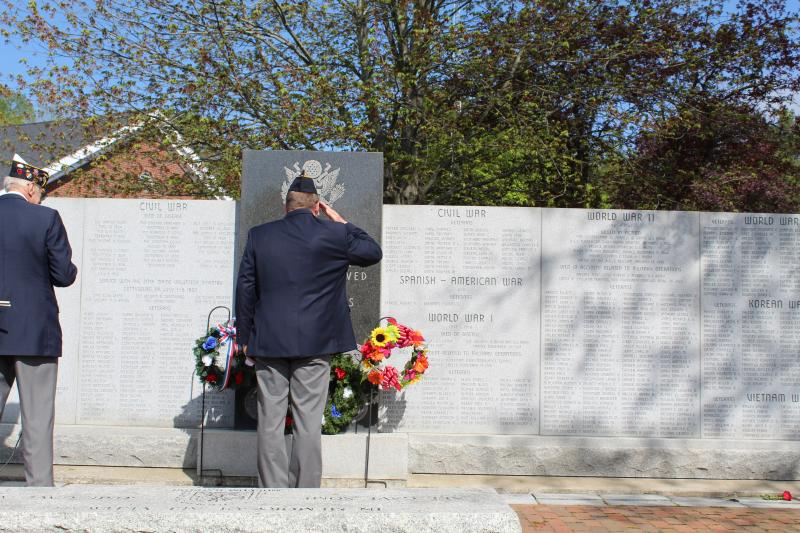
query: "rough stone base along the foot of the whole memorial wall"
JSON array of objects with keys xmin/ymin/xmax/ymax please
[{"xmin": 0, "ymin": 424, "xmax": 800, "ymax": 487}]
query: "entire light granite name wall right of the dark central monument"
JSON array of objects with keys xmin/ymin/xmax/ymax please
[{"xmin": 381, "ymin": 206, "xmax": 800, "ymax": 440}]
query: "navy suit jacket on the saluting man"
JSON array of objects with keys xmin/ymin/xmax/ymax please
[{"xmin": 236, "ymin": 209, "xmax": 382, "ymax": 357}]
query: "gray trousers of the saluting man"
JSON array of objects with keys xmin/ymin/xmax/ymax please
[{"xmin": 255, "ymin": 355, "xmax": 331, "ymax": 488}]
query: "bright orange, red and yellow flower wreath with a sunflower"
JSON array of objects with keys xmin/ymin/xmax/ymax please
[{"xmin": 358, "ymin": 317, "xmax": 428, "ymax": 391}]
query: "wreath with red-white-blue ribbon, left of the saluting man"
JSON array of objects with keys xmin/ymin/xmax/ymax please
[{"xmin": 193, "ymin": 321, "xmax": 255, "ymax": 391}]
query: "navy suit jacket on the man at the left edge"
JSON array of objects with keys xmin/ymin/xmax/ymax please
[{"xmin": 0, "ymin": 194, "xmax": 78, "ymax": 357}]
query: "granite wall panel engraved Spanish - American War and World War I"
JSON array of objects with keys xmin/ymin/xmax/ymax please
[{"xmin": 381, "ymin": 205, "xmax": 541, "ymax": 434}]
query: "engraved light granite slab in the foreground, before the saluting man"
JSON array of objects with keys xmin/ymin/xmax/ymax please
[{"xmin": 0, "ymin": 485, "xmax": 521, "ymax": 533}]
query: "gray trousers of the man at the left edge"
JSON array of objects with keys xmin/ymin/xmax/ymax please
[{"xmin": 0, "ymin": 356, "xmax": 58, "ymax": 487}]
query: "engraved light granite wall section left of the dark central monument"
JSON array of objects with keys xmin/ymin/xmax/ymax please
[{"xmin": 3, "ymin": 198, "xmax": 235, "ymax": 427}]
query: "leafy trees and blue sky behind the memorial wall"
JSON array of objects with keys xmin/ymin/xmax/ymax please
[{"xmin": 3, "ymin": 0, "xmax": 800, "ymax": 211}]
